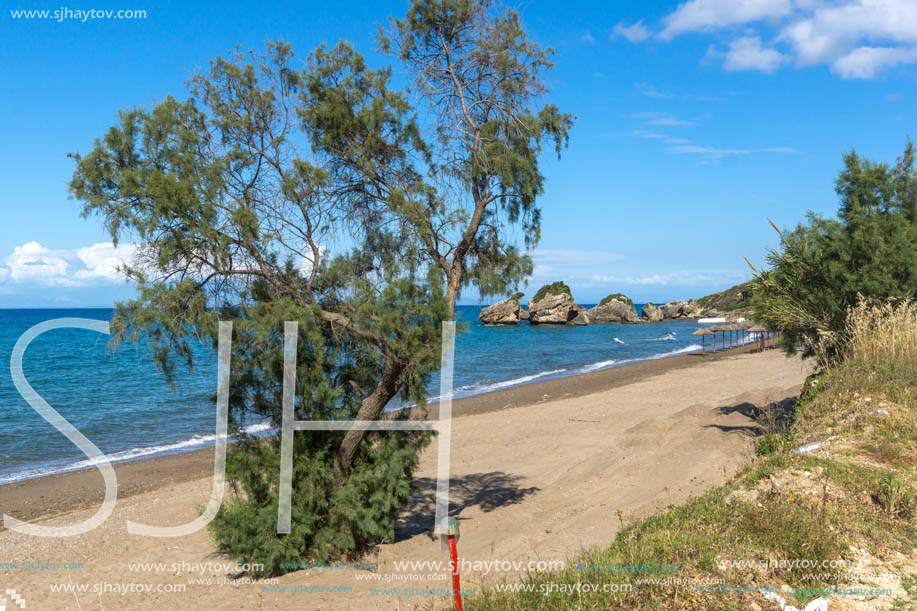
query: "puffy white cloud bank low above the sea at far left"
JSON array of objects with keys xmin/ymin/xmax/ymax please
[{"xmin": 0, "ymin": 242, "xmax": 136, "ymax": 287}]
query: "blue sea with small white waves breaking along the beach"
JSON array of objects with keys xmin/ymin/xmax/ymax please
[{"xmin": 0, "ymin": 304, "xmax": 728, "ymax": 484}]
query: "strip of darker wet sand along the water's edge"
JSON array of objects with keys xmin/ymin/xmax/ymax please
[{"xmin": 0, "ymin": 344, "xmax": 772, "ymax": 532}]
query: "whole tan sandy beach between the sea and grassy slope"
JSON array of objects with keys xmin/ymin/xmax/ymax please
[{"xmin": 0, "ymin": 349, "xmax": 809, "ymax": 611}]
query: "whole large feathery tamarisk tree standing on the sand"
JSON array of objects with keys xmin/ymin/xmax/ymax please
[{"xmin": 71, "ymin": 2, "xmax": 572, "ymax": 574}]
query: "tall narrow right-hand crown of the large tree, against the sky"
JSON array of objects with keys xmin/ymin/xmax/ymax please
[{"xmin": 379, "ymin": 0, "xmax": 573, "ymax": 304}]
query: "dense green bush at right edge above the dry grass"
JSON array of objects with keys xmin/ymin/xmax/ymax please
[{"xmin": 752, "ymin": 142, "xmax": 917, "ymax": 366}]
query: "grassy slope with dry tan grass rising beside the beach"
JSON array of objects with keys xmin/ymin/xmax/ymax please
[{"xmin": 466, "ymin": 303, "xmax": 917, "ymax": 610}]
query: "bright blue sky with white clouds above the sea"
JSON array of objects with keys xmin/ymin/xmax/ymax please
[{"xmin": 0, "ymin": 0, "xmax": 917, "ymax": 307}]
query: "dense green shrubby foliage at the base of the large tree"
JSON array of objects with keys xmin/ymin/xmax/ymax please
[{"xmin": 212, "ymin": 424, "xmax": 429, "ymax": 575}]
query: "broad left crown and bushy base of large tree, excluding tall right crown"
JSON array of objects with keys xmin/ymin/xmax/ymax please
[{"xmin": 71, "ymin": 39, "xmax": 451, "ymax": 574}]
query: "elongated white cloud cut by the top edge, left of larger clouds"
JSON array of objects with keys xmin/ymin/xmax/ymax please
[{"xmin": 659, "ymin": 0, "xmax": 793, "ymax": 40}]
